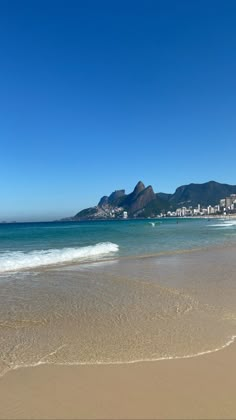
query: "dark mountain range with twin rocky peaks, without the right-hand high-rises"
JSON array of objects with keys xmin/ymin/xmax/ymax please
[{"xmin": 69, "ymin": 181, "xmax": 236, "ymax": 220}]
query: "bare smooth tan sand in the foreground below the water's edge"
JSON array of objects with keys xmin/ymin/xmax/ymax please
[{"xmin": 0, "ymin": 343, "xmax": 236, "ymax": 419}]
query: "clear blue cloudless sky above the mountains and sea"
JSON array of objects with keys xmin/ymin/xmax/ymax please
[{"xmin": 0, "ymin": 0, "xmax": 236, "ymax": 220}]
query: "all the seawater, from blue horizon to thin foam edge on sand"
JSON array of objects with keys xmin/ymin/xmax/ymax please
[{"xmin": 0, "ymin": 218, "xmax": 236, "ymax": 375}]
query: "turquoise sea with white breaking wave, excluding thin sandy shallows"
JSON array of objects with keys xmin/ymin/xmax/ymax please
[{"xmin": 0, "ymin": 219, "xmax": 236, "ymax": 273}]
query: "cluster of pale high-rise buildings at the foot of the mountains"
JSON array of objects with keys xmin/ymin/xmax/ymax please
[{"xmin": 166, "ymin": 194, "xmax": 236, "ymax": 217}]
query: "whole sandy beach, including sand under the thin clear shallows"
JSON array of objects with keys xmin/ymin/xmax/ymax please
[{"xmin": 0, "ymin": 230, "xmax": 236, "ymax": 419}]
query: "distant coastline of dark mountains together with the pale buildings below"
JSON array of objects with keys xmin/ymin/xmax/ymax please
[{"xmin": 69, "ymin": 181, "xmax": 236, "ymax": 221}]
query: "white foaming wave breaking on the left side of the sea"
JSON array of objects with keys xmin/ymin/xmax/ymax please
[{"xmin": 0, "ymin": 242, "xmax": 119, "ymax": 273}]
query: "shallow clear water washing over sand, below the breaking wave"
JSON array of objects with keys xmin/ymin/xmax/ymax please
[{"xmin": 0, "ymin": 247, "xmax": 236, "ymax": 374}]
